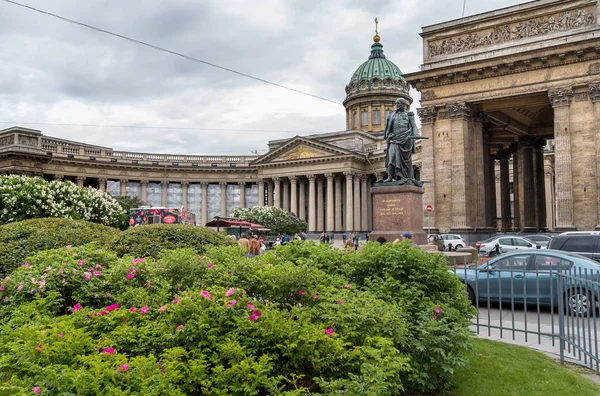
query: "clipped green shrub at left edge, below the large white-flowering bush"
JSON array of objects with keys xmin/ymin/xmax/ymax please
[{"xmin": 0, "ymin": 218, "xmax": 121, "ymax": 275}]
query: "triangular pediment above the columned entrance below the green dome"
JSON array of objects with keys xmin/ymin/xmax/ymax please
[{"xmin": 252, "ymin": 136, "xmax": 352, "ymax": 165}]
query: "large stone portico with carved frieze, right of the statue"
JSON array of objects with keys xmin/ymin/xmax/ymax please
[{"xmin": 405, "ymin": 0, "xmax": 600, "ymax": 234}]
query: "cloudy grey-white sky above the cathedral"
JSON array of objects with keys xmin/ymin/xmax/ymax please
[{"xmin": 0, "ymin": 0, "xmax": 522, "ymax": 155}]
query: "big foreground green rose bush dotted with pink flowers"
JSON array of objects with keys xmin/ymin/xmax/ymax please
[{"xmin": 0, "ymin": 243, "xmax": 472, "ymax": 395}]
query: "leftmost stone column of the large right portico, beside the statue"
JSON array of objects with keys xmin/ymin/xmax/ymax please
[{"xmin": 418, "ymin": 106, "xmax": 437, "ymax": 230}]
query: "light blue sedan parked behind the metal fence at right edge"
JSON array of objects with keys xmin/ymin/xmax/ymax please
[{"xmin": 455, "ymin": 250, "xmax": 600, "ymax": 316}]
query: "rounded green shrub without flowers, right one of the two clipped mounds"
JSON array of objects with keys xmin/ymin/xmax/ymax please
[{"xmin": 111, "ymin": 224, "xmax": 232, "ymax": 257}]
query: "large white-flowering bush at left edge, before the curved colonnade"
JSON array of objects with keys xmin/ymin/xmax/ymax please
[{"xmin": 0, "ymin": 175, "xmax": 125, "ymax": 227}]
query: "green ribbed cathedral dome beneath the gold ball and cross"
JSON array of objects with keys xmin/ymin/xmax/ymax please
[{"xmin": 346, "ymin": 36, "xmax": 412, "ymax": 102}]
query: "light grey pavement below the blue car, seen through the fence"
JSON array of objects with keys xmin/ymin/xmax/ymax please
[{"xmin": 471, "ymin": 304, "xmax": 600, "ymax": 369}]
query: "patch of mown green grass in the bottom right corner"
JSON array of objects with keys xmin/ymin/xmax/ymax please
[{"xmin": 451, "ymin": 338, "xmax": 600, "ymax": 396}]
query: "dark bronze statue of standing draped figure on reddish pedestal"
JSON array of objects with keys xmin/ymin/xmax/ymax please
[{"xmin": 378, "ymin": 98, "xmax": 423, "ymax": 187}]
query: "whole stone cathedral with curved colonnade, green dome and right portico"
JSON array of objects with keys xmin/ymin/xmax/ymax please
[{"xmin": 0, "ymin": 0, "xmax": 600, "ymax": 243}]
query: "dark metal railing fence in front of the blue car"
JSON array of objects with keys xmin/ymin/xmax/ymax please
[{"xmin": 451, "ymin": 256, "xmax": 600, "ymax": 372}]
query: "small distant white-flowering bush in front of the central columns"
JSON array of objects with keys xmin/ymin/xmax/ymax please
[{"xmin": 233, "ymin": 206, "xmax": 308, "ymax": 234}]
